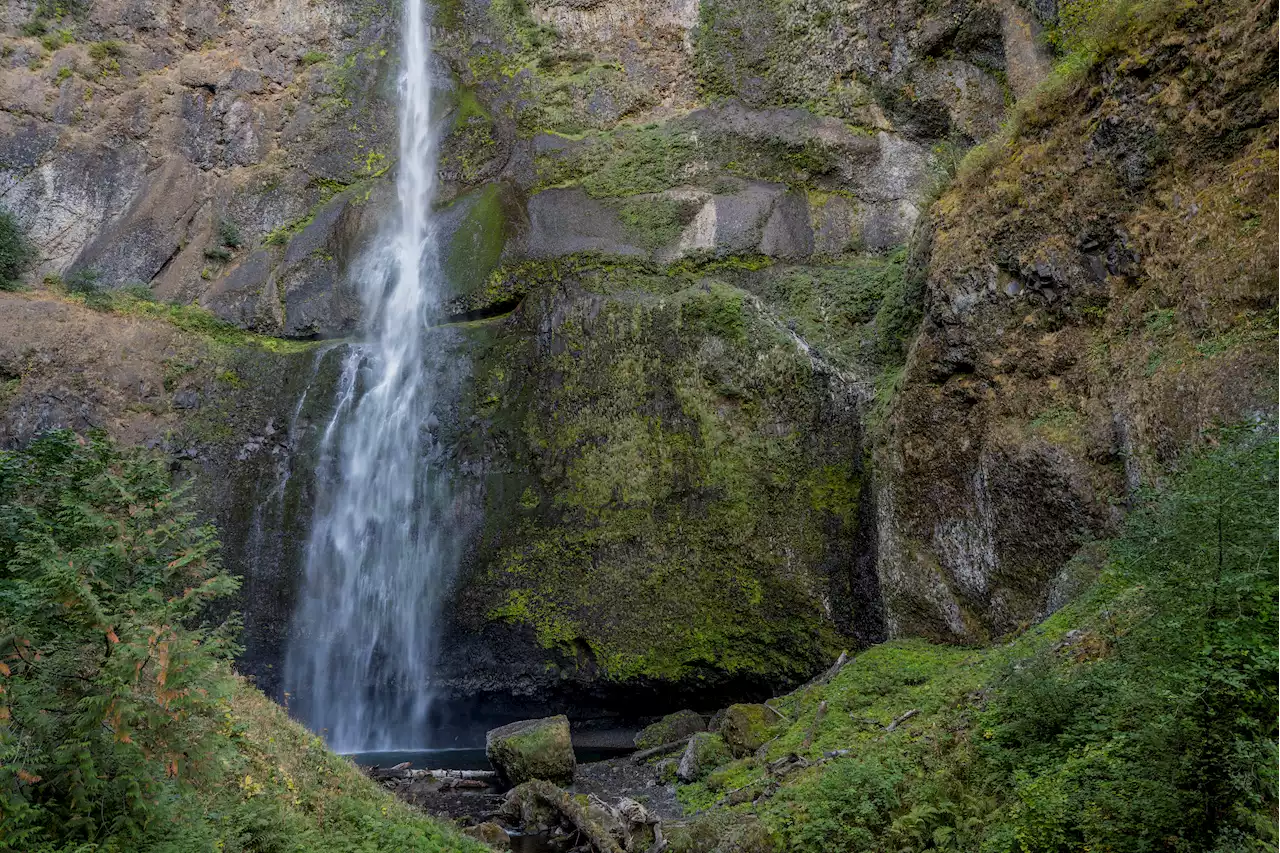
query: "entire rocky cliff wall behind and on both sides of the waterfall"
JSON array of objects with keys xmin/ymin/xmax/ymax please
[{"xmin": 17, "ymin": 0, "xmax": 1276, "ymax": 732}]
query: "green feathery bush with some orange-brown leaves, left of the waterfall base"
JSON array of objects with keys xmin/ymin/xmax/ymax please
[{"xmin": 0, "ymin": 432, "xmax": 238, "ymax": 849}]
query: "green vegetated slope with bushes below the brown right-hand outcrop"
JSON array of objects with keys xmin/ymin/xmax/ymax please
[{"xmin": 676, "ymin": 429, "xmax": 1280, "ymax": 853}]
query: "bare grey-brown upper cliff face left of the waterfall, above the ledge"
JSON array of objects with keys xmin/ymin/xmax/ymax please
[{"xmin": 0, "ymin": 0, "xmax": 396, "ymax": 337}]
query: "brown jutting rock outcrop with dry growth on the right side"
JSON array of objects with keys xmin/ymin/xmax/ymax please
[{"xmin": 874, "ymin": 0, "xmax": 1280, "ymax": 640}]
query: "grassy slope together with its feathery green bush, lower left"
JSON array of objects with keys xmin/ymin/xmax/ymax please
[{"xmin": 0, "ymin": 432, "xmax": 481, "ymax": 853}]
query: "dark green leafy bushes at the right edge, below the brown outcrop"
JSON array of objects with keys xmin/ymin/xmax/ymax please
[{"xmin": 986, "ymin": 434, "xmax": 1280, "ymax": 853}]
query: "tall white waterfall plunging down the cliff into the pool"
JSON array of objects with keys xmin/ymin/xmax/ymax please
[{"xmin": 284, "ymin": 0, "xmax": 454, "ymax": 752}]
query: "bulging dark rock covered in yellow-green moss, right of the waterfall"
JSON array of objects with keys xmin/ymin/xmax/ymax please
[{"xmin": 461, "ymin": 252, "xmax": 860, "ymax": 683}]
